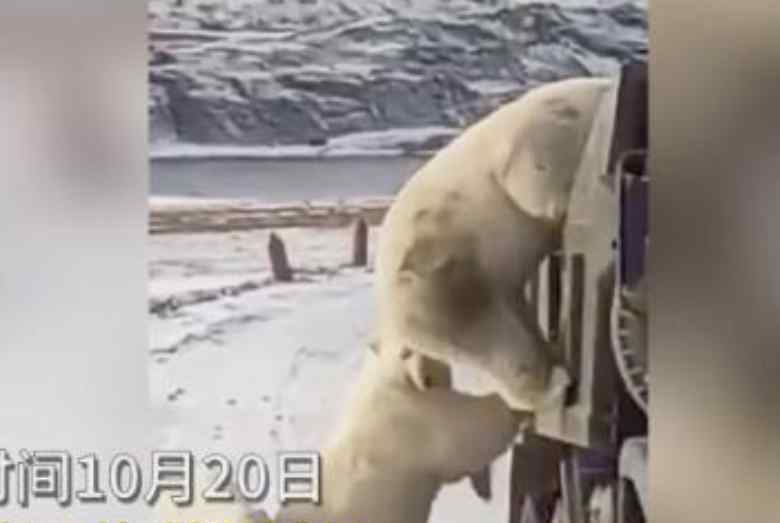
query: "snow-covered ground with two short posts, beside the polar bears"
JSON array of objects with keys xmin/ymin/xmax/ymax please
[{"xmin": 149, "ymin": 200, "xmax": 509, "ymax": 523}]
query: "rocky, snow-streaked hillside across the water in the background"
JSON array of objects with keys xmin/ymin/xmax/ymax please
[{"xmin": 149, "ymin": 0, "xmax": 647, "ymax": 155}]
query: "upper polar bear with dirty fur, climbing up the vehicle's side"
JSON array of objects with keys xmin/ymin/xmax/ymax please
[{"xmin": 376, "ymin": 78, "xmax": 613, "ymax": 411}]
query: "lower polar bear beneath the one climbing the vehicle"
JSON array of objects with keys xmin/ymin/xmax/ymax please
[{"xmin": 266, "ymin": 345, "xmax": 527, "ymax": 523}]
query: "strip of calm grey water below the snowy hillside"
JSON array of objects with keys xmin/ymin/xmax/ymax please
[{"xmin": 150, "ymin": 157, "xmax": 425, "ymax": 203}]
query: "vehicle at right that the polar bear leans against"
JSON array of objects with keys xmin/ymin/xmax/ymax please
[{"xmin": 509, "ymin": 62, "xmax": 650, "ymax": 523}]
